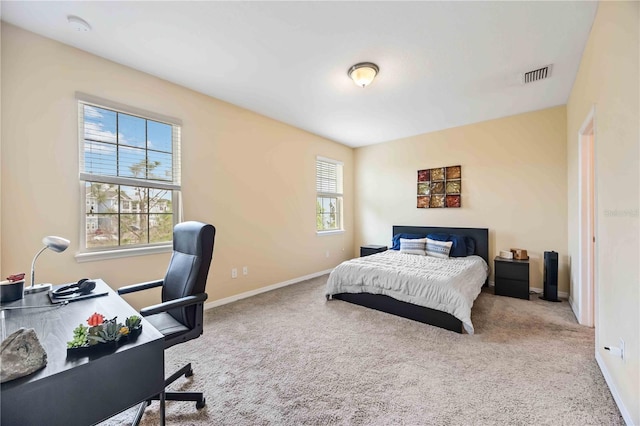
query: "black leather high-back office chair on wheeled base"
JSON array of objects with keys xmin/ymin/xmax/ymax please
[{"xmin": 118, "ymin": 222, "xmax": 216, "ymax": 425}]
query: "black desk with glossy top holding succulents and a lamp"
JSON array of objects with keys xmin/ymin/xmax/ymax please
[{"xmin": 0, "ymin": 280, "xmax": 164, "ymax": 426}]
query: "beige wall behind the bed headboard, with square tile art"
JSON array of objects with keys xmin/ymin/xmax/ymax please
[{"xmin": 355, "ymin": 106, "xmax": 568, "ymax": 292}]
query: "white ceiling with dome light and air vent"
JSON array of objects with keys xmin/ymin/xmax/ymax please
[{"xmin": 0, "ymin": 1, "xmax": 597, "ymax": 147}]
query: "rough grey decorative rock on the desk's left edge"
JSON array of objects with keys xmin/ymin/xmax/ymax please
[{"xmin": 0, "ymin": 328, "xmax": 47, "ymax": 383}]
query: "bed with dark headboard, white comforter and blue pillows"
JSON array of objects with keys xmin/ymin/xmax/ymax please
[{"xmin": 326, "ymin": 226, "xmax": 489, "ymax": 334}]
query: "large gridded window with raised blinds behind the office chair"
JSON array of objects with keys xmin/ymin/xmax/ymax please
[{"xmin": 78, "ymin": 95, "xmax": 181, "ymax": 251}]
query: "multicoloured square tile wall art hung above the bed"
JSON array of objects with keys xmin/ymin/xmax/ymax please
[{"xmin": 418, "ymin": 166, "xmax": 462, "ymax": 209}]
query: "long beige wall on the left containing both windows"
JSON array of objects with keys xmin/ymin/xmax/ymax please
[{"xmin": 1, "ymin": 23, "xmax": 353, "ymax": 306}]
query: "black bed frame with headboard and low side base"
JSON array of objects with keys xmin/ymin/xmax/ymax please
[{"xmin": 332, "ymin": 225, "xmax": 489, "ymax": 333}]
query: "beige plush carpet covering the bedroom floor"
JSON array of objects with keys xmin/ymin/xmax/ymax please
[{"xmin": 105, "ymin": 276, "xmax": 624, "ymax": 425}]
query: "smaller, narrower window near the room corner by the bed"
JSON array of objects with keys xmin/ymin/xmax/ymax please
[{"xmin": 316, "ymin": 157, "xmax": 342, "ymax": 232}]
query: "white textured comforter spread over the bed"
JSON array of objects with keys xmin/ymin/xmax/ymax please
[{"xmin": 326, "ymin": 250, "xmax": 489, "ymax": 334}]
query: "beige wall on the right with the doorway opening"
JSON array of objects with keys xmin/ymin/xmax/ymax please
[{"xmin": 567, "ymin": 2, "xmax": 640, "ymax": 424}]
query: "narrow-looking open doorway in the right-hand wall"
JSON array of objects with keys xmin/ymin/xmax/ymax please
[{"xmin": 577, "ymin": 106, "xmax": 596, "ymax": 327}]
